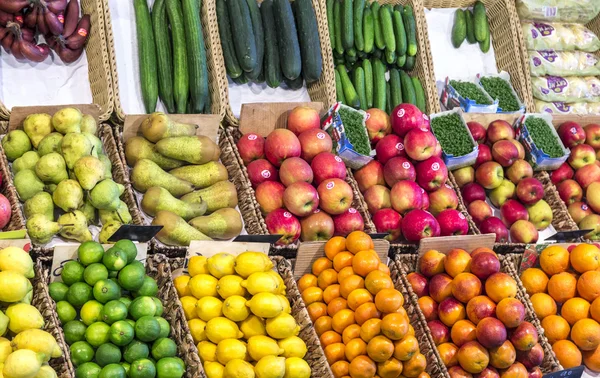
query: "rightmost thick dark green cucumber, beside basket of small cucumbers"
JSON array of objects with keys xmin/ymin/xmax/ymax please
[{"xmin": 292, "ymin": 0, "xmax": 323, "ymax": 84}]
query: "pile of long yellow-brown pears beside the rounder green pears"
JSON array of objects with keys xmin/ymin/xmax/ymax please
[{"xmin": 125, "ymin": 112, "xmax": 243, "ymax": 246}]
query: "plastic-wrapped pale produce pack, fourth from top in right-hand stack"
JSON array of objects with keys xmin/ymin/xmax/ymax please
[{"xmin": 531, "ymin": 76, "xmax": 600, "ymax": 102}]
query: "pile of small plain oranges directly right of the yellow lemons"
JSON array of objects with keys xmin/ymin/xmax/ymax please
[{"xmin": 298, "ymin": 231, "xmax": 429, "ymax": 378}]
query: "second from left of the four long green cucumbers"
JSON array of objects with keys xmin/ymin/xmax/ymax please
[{"xmin": 152, "ymin": 0, "xmax": 175, "ymax": 113}]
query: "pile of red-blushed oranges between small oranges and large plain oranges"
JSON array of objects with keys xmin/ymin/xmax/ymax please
[{"xmin": 407, "ymin": 247, "xmax": 544, "ymax": 377}]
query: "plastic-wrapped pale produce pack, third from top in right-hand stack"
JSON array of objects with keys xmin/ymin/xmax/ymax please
[{"xmin": 529, "ymin": 50, "xmax": 600, "ymax": 76}]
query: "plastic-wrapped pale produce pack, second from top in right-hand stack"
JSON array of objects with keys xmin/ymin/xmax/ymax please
[{"xmin": 522, "ymin": 22, "xmax": 600, "ymax": 52}]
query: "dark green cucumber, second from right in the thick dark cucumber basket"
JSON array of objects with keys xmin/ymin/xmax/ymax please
[{"xmin": 274, "ymin": 0, "xmax": 302, "ymax": 80}]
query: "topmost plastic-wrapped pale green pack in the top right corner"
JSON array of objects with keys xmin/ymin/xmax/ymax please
[{"xmin": 516, "ymin": 0, "xmax": 600, "ymax": 24}]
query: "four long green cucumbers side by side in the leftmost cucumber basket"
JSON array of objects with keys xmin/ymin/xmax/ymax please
[{"xmin": 133, "ymin": 0, "xmax": 210, "ymax": 114}]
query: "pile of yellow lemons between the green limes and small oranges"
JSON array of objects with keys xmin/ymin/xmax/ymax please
[{"xmin": 174, "ymin": 252, "xmax": 311, "ymax": 378}]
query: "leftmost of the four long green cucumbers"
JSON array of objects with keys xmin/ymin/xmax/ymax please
[{"xmin": 133, "ymin": 0, "xmax": 158, "ymax": 114}]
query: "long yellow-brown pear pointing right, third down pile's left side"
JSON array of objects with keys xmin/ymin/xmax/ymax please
[{"xmin": 131, "ymin": 159, "xmax": 194, "ymax": 197}]
